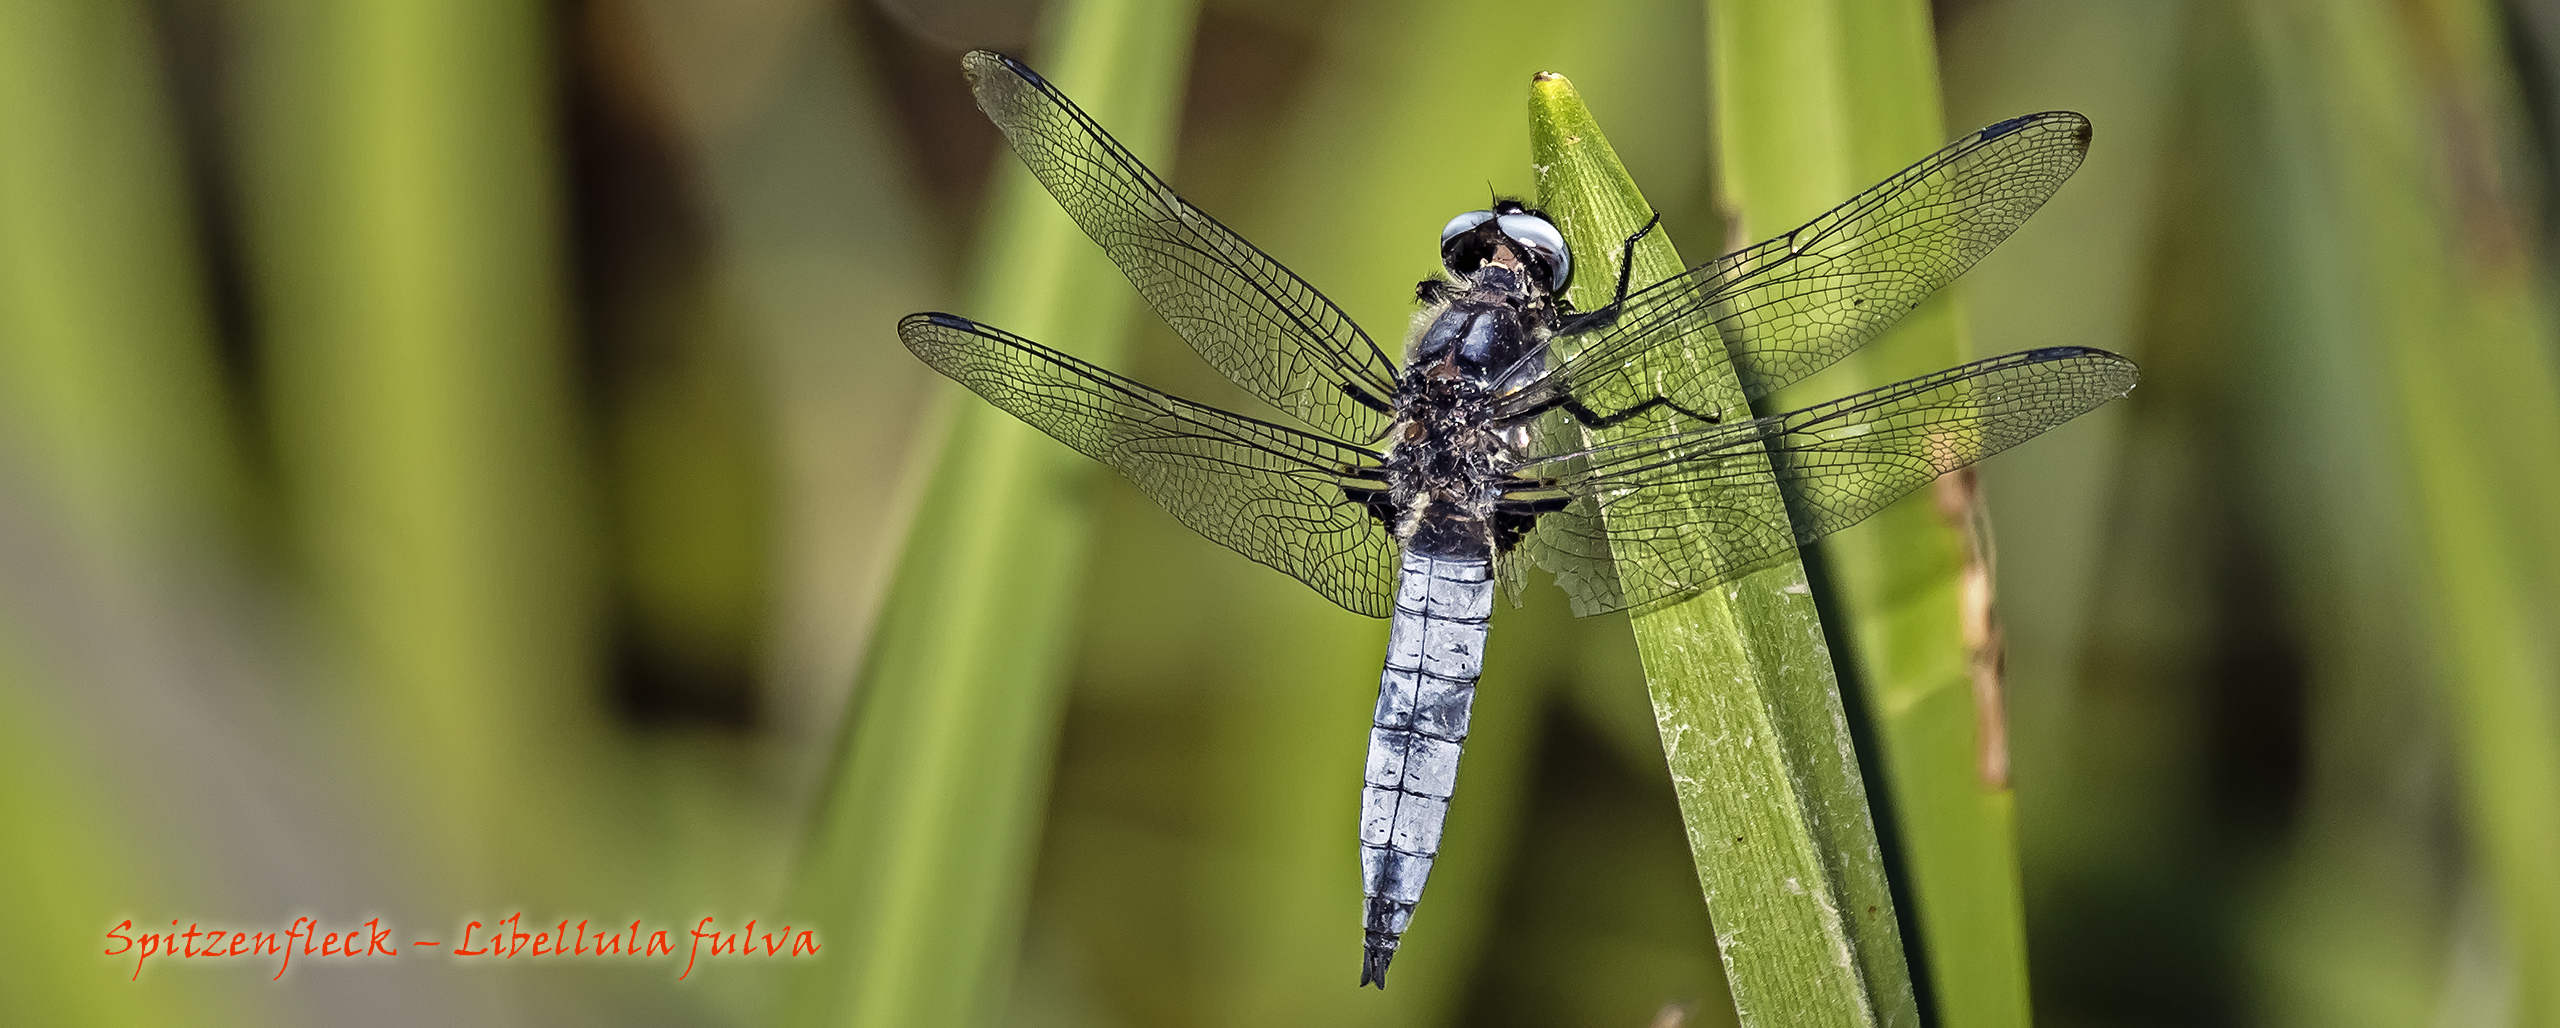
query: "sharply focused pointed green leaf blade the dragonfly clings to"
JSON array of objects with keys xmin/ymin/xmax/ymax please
[{"xmin": 1531, "ymin": 74, "xmax": 1917, "ymax": 1025}]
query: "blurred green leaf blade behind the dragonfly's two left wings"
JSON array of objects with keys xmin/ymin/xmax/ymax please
[{"xmin": 783, "ymin": 0, "xmax": 1196, "ymax": 1028}]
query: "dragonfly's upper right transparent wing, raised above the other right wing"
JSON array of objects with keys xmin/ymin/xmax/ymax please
[{"xmin": 1508, "ymin": 110, "xmax": 2089, "ymax": 429}]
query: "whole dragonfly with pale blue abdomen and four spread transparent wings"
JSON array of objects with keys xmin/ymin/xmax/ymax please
[{"xmin": 899, "ymin": 51, "xmax": 2138, "ymax": 990}]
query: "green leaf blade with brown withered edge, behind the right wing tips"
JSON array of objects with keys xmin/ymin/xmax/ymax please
[{"xmin": 1708, "ymin": 0, "xmax": 2066, "ymax": 1028}]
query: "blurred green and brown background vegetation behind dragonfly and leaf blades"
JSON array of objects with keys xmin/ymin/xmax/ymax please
[{"xmin": 0, "ymin": 0, "xmax": 2560, "ymax": 1028}]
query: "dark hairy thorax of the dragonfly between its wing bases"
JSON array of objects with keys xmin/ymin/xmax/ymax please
[{"xmin": 1385, "ymin": 251, "xmax": 1556, "ymax": 560}]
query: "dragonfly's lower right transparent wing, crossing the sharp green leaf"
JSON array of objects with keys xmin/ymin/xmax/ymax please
[{"xmin": 1516, "ymin": 348, "xmax": 2138, "ymax": 614}]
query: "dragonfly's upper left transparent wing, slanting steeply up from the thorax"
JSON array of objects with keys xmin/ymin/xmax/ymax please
[{"xmin": 963, "ymin": 51, "xmax": 1395, "ymax": 440}]
